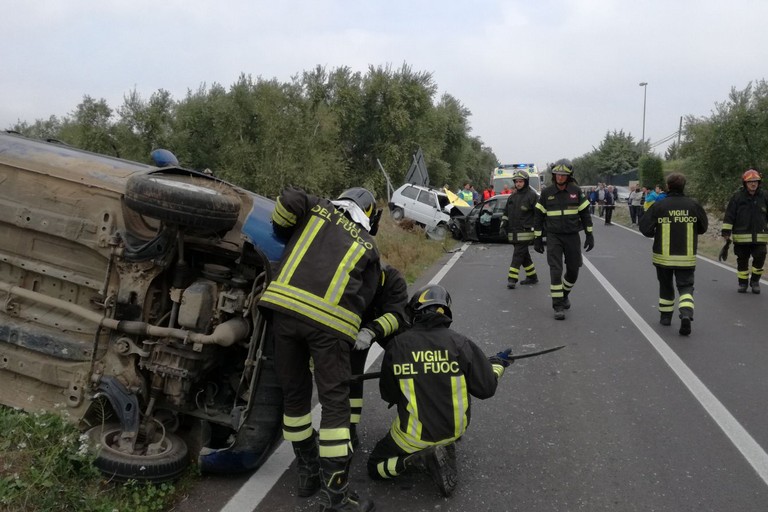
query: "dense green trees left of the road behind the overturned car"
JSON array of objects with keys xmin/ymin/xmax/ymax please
[{"xmin": 12, "ymin": 64, "xmax": 497, "ymax": 201}]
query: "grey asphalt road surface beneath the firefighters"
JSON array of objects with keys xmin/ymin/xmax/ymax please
[{"xmin": 175, "ymin": 219, "xmax": 768, "ymax": 512}]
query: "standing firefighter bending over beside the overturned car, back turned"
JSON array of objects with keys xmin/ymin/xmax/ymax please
[{"xmin": 259, "ymin": 187, "xmax": 381, "ymax": 511}]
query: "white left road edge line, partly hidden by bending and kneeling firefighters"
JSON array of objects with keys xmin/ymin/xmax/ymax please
[{"xmin": 221, "ymin": 243, "xmax": 470, "ymax": 512}]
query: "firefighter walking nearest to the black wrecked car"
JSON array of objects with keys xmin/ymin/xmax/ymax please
[{"xmin": 501, "ymin": 170, "xmax": 539, "ymax": 289}]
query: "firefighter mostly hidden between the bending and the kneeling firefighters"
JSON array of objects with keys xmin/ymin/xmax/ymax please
[{"xmin": 349, "ymin": 264, "xmax": 408, "ymax": 449}]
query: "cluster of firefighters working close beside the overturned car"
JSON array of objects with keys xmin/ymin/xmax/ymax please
[{"xmin": 259, "ymin": 187, "xmax": 511, "ymax": 512}]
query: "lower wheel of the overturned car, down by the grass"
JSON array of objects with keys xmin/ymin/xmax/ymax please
[{"xmin": 86, "ymin": 423, "xmax": 189, "ymax": 482}]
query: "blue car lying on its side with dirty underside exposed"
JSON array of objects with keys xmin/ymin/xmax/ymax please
[{"xmin": 0, "ymin": 133, "xmax": 284, "ymax": 481}]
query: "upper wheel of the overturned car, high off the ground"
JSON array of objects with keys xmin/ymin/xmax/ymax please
[{"xmin": 125, "ymin": 174, "xmax": 240, "ymax": 231}]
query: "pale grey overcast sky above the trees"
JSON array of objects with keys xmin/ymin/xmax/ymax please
[{"xmin": 0, "ymin": 0, "xmax": 768, "ymax": 170}]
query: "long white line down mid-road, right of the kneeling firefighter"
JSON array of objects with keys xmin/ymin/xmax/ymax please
[{"xmin": 584, "ymin": 258, "xmax": 768, "ymax": 484}]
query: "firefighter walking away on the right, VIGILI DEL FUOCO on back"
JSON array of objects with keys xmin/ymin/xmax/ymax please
[{"xmin": 640, "ymin": 172, "xmax": 708, "ymax": 336}]
